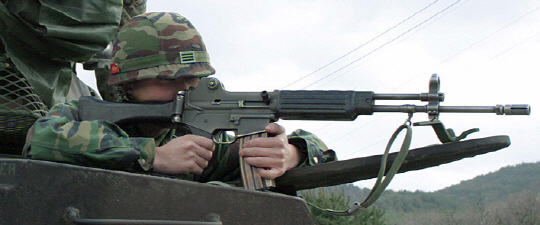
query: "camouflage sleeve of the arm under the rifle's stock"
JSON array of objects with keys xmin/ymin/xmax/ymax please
[{"xmin": 27, "ymin": 101, "xmax": 155, "ymax": 171}]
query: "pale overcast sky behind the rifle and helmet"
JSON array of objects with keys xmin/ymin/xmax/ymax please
[{"xmin": 80, "ymin": 0, "xmax": 540, "ymax": 191}]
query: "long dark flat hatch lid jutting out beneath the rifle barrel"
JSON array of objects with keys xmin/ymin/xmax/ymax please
[{"xmin": 275, "ymin": 136, "xmax": 510, "ymax": 190}]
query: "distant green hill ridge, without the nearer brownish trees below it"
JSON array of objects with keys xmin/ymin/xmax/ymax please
[{"xmin": 374, "ymin": 162, "xmax": 540, "ymax": 212}]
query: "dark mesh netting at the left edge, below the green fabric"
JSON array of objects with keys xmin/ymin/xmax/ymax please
[{"xmin": 0, "ymin": 52, "xmax": 48, "ymax": 154}]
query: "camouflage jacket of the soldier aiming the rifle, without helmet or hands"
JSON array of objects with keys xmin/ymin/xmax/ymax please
[{"xmin": 26, "ymin": 101, "xmax": 335, "ymax": 184}]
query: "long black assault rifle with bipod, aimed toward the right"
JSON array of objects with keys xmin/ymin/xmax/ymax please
[{"xmin": 79, "ymin": 74, "xmax": 530, "ymax": 193}]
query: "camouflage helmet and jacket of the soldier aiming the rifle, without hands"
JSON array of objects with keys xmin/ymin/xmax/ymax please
[{"xmin": 27, "ymin": 13, "xmax": 335, "ymax": 185}]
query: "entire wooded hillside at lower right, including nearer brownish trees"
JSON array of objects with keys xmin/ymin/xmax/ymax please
[{"xmin": 304, "ymin": 162, "xmax": 540, "ymax": 224}]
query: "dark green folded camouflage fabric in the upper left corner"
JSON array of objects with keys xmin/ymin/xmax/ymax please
[{"xmin": 0, "ymin": 0, "xmax": 146, "ymax": 108}]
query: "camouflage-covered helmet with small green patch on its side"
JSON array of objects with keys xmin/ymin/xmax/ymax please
[{"xmin": 108, "ymin": 12, "xmax": 215, "ymax": 86}]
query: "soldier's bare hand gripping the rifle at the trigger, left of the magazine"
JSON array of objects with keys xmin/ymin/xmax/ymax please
[{"xmin": 154, "ymin": 135, "xmax": 214, "ymax": 174}]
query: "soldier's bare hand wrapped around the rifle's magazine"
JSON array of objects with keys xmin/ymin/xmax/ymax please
[{"xmin": 240, "ymin": 123, "xmax": 301, "ymax": 179}]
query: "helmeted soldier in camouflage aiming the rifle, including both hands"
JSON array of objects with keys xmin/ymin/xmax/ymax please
[{"xmin": 27, "ymin": 13, "xmax": 335, "ymax": 185}]
